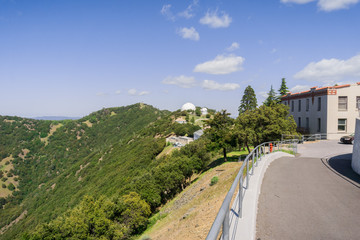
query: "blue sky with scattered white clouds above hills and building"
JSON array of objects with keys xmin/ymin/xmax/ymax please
[{"xmin": 0, "ymin": 0, "xmax": 360, "ymax": 117}]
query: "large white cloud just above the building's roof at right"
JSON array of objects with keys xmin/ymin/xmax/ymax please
[{"xmin": 294, "ymin": 54, "xmax": 360, "ymax": 82}]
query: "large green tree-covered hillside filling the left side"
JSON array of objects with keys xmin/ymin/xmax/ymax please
[{"xmin": 0, "ymin": 104, "xmax": 210, "ymax": 239}]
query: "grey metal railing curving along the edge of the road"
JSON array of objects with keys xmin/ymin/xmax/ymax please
[{"xmin": 206, "ymin": 139, "xmax": 298, "ymax": 240}]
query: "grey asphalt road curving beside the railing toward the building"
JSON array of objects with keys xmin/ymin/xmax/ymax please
[{"xmin": 256, "ymin": 141, "xmax": 360, "ymax": 240}]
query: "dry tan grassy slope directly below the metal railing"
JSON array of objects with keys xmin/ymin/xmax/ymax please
[{"xmin": 139, "ymin": 162, "xmax": 242, "ymax": 240}]
